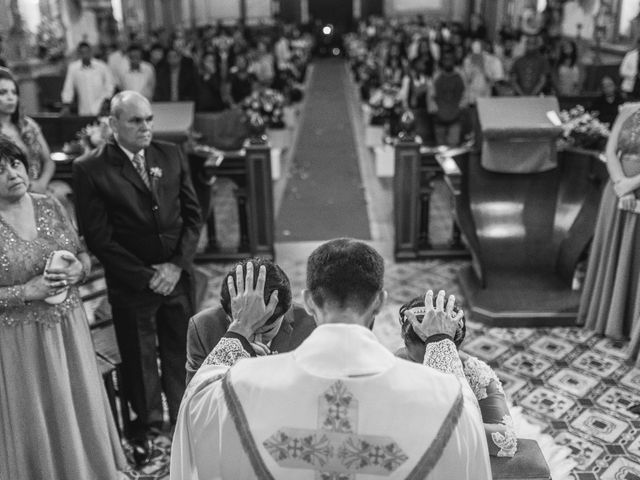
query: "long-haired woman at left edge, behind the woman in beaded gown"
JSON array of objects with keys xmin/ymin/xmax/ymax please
[{"xmin": 0, "ymin": 68, "xmax": 55, "ymax": 193}]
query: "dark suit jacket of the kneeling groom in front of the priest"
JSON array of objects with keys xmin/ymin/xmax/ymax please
[{"xmin": 187, "ymin": 305, "xmax": 316, "ymax": 383}]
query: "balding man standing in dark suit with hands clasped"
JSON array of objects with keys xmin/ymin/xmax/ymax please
[{"xmin": 73, "ymin": 91, "xmax": 201, "ymax": 464}]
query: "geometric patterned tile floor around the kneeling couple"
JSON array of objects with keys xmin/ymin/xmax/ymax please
[{"xmin": 100, "ymin": 172, "xmax": 640, "ymax": 480}]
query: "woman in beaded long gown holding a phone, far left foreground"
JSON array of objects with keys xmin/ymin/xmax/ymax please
[{"xmin": 0, "ymin": 139, "xmax": 125, "ymax": 480}]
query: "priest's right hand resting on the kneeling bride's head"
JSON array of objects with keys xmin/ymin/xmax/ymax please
[{"xmin": 404, "ymin": 290, "xmax": 464, "ymax": 341}]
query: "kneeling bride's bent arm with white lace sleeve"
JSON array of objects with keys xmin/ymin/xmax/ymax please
[{"xmin": 464, "ymin": 357, "xmax": 518, "ymax": 457}]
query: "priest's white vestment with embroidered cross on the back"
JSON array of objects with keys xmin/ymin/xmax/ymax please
[{"xmin": 171, "ymin": 324, "xmax": 491, "ymax": 480}]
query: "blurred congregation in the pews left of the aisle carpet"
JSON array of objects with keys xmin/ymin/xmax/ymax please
[{"xmin": 48, "ymin": 20, "xmax": 311, "ymax": 135}]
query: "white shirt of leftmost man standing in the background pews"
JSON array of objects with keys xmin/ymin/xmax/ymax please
[{"xmin": 61, "ymin": 58, "xmax": 114, "ymax": 115}]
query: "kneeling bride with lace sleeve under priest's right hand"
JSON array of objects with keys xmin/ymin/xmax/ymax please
[{"xmin": 396, "ymin": 296, "xmax": 518, "ymax": 457}]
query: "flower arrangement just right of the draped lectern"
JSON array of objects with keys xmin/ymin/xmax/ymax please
[{"xmin": 558, "ymin": 105, "xmax": 609, "ymax": 150}]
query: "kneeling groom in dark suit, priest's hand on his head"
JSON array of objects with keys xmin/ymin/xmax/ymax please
[{"xmin": 187, "ymin": 258, "xmax": 316, "ymax": 383}]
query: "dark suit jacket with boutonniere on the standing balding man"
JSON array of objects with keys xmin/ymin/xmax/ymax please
[{"xmin": 73, "ymin": 141, "xmax": 201, "ymax": 306}]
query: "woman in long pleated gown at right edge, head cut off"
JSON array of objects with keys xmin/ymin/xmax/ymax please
[{"xmin": 578, "ymin": 104, "xmax": 640, "ymax": 365}]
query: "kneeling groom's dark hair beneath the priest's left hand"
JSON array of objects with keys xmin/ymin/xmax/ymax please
[{"xmin": 220, "ymin": 258, "xmax": 292, "ymax": 325}]
